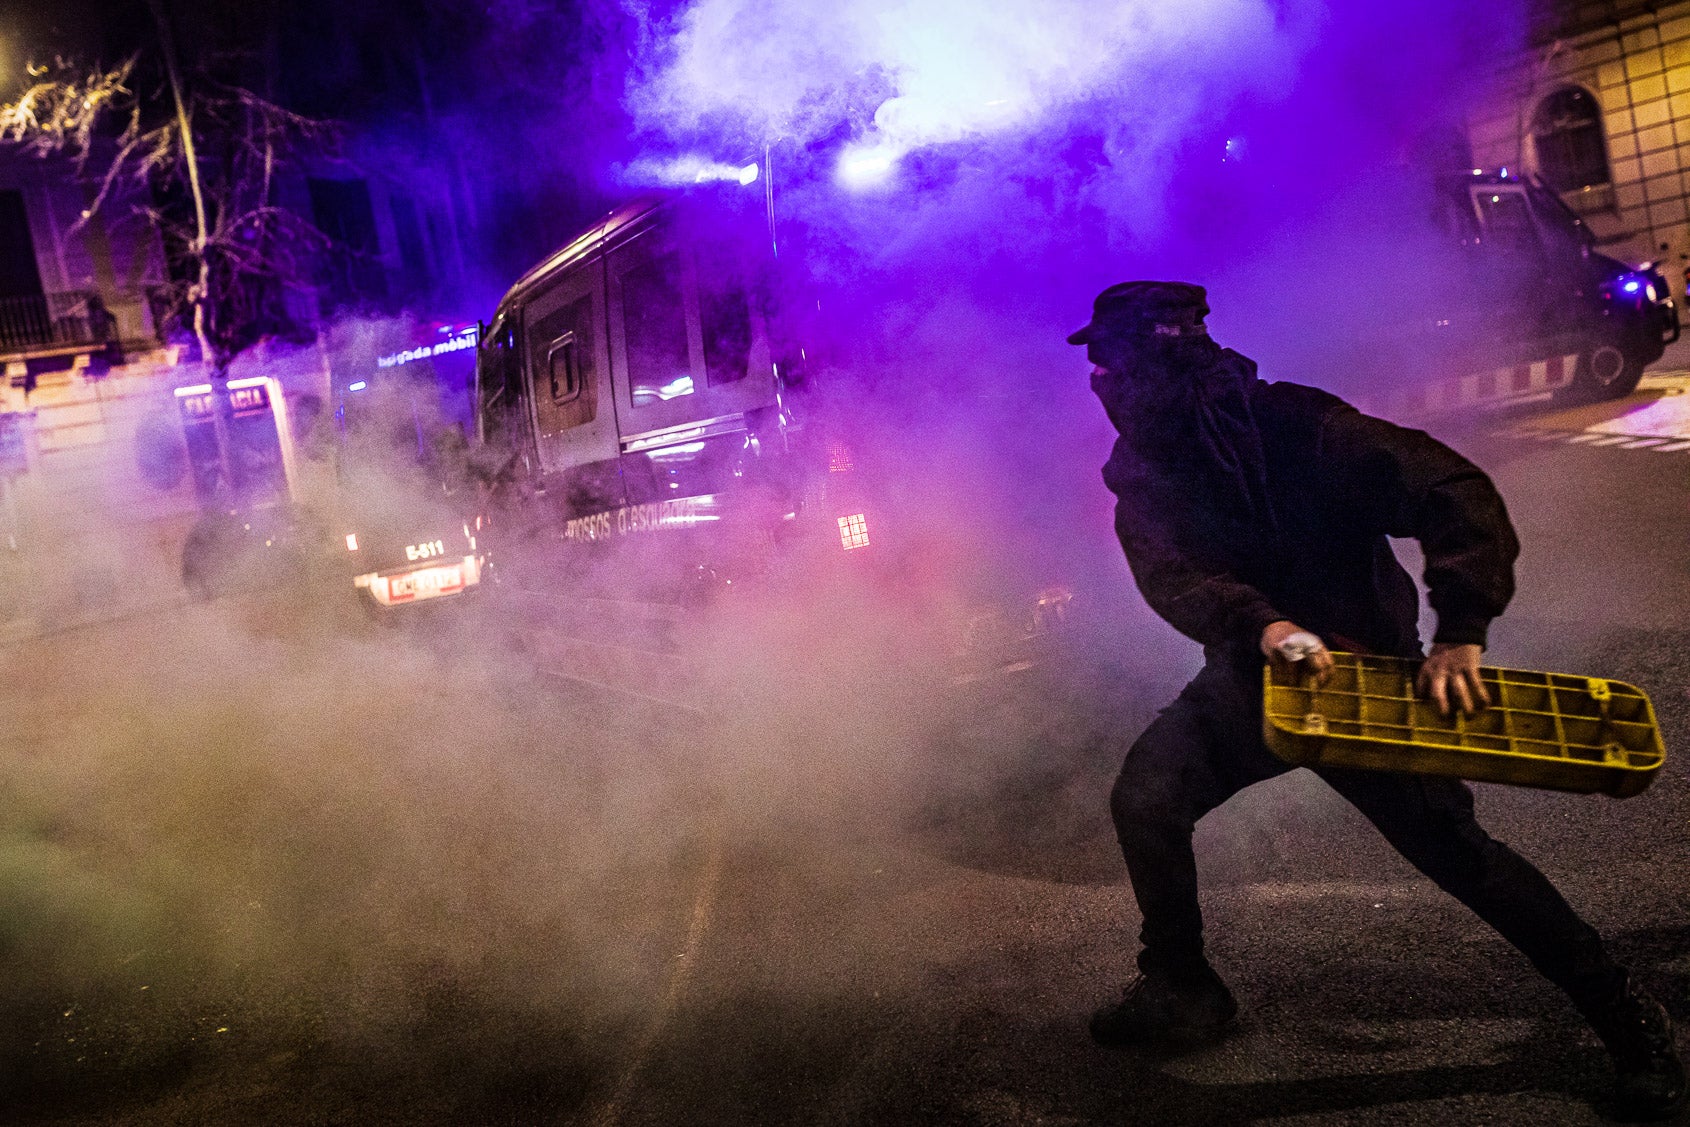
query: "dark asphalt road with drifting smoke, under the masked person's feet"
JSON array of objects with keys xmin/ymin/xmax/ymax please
[{"xmin": 0, "ymin": 375, "xmax": 1690, "ymax": 1127}]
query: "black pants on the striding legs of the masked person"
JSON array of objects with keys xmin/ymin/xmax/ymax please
[{"xmin": 1110, "ymin": 662, "xmax": 1626, "ymax": 1015}]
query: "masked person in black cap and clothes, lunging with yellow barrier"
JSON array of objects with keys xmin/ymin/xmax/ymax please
[{"xmin": 1068, "ymin": 282, "xmax": 1685, "ymax": 1115}]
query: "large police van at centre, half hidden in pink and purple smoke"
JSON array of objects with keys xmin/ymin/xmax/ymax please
[{"xmin": 472, "ymin": 194, "xmax": 1071, "ymax": 698}]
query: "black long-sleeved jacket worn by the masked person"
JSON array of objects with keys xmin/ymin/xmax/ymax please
[{"xmin": 1104, "ymin": 361, "xmax": 1519, "ymax": 659}]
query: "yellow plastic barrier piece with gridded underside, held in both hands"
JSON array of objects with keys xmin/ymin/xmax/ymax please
[{"xmin": 1262, "ymin": 652, "xmax": 1666, "ymax": 798}]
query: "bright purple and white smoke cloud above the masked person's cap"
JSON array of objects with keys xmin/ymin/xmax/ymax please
[{"xmin": 624, "ymin": 0, "xmax": 1523, "ymax": 366}]
